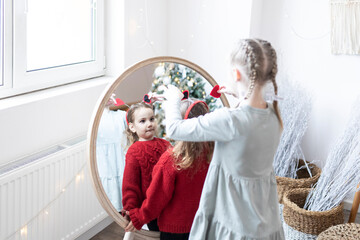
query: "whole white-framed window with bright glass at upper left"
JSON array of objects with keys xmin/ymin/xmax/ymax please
[{"xmin": 0, "ymin": 0, "xmax": 104, "ymax": 98}]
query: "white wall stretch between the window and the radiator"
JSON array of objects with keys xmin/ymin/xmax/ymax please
[{"xmin": 0, "ymin": 79, "xmax": 108, "ymax": 166}]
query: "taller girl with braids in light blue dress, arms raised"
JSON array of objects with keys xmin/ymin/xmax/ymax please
[{"xmin": 164, "ymin": 39, "xmax": 284, "ymax": 240}]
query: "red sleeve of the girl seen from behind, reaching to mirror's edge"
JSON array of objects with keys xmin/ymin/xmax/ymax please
[{"xmin": 130, "ymin": 152, "xmax": 175, "ymax": 229}]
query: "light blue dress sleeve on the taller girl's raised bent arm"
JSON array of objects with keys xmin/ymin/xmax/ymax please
[{"xmin": 165, "ymin": 99, "xmax": 236, "ymax": 142}]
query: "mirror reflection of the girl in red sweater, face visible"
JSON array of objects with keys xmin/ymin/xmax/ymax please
[{"xmin": 122, "ymin": 102, "xmax": 170, "ymax": 231}]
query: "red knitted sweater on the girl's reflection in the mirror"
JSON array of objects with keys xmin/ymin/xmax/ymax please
[{"xmin": 122, "ymin": 138, "xmax": 170, "ymax": 211}]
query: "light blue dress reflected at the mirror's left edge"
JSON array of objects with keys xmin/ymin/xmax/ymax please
[{"xmin": 96, "ymin": 108, "xmax": 127, "ymax": 211}]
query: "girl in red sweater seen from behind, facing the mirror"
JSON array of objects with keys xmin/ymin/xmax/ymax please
[{"xmin": 125, "ymin": 99, "xmax": 214, "ymax": 240}]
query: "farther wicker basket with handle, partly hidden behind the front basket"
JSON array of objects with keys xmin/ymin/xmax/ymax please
[{"xmin": 276, "ymin": 159, "xmax": 321, "ymax": 204}]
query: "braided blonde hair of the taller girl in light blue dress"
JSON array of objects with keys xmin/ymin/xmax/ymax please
[{"xmin": 230, "ymin": 39, "xmax": 283, "ymax": 127}]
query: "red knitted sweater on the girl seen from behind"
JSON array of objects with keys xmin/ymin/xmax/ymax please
[{"xmin": 130, "ymin": 149, "xmax": 209, "ymax": 233}]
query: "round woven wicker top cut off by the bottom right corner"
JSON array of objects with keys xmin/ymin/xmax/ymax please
[{"xmin": 317, "ymin": 223, "xmax": 360, "ymax": 240}]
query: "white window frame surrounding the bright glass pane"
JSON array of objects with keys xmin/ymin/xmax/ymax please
[{"xmin": 0, "ymin": 0, "xmax": 105, "ymax": 99}]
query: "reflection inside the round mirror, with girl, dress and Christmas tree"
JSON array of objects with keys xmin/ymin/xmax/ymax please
[{"xmin": 96, "ymin": 62, "xmax": 223, "ymax": 233}]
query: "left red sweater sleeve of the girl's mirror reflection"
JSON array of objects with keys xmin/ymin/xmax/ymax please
[{"xmin": 122, "ymin": 149, "xmax": 142, "ymax": 211}]
